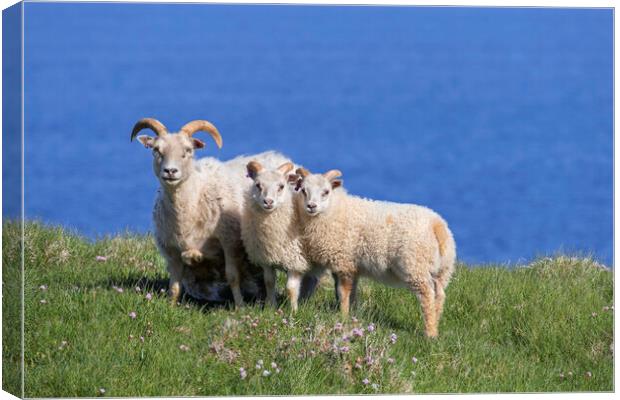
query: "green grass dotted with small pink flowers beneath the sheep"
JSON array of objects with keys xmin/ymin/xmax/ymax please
[{"xmin": 2, "ymin": 223, "xmax": 613, "ymax": 397}]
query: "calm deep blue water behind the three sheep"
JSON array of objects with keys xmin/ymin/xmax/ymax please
[{"xmin": 9, "ymin": 3, "xmax": 613, "ymax": 264}]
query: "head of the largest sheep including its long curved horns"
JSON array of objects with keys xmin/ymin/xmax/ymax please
[{"xmin": 131, "ymin": 118, "xmax": 222, "ymax": 187}]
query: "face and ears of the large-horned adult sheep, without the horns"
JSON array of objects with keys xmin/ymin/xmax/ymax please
[{"xmin": 140, "ymin": 134, "xmax": 204, "ymax": 187}]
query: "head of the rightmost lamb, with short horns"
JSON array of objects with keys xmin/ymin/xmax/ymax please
[{"xmin": 295, "ymin": 168, "xmax": 342, "ymax": 216}]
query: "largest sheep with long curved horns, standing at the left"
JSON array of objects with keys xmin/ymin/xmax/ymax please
[{"xmin": 131, "ymin": 118, "xmax": 286, "ymax": 307}]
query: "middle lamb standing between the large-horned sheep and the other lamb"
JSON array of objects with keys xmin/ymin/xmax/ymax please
[{"xmin": 241, "ymin": 161, "xmax": 322, "ymax": 312}]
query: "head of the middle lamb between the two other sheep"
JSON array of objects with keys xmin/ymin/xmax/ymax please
[{"xmin": 246, "ymin": 161, "xmax": 297, "ymax": 212}]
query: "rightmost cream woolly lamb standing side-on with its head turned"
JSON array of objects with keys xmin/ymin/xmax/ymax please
[{"xmin": 296, "ymin": 169, "xmax": 456, "ymax": 337}]
